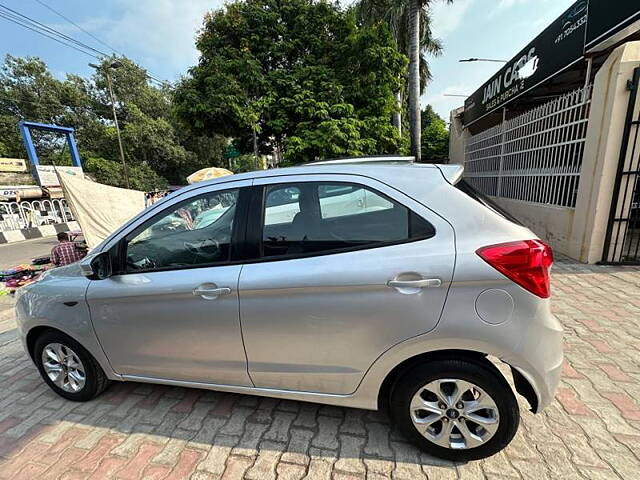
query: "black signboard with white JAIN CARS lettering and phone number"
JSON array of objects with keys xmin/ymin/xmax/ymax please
[{"xmin": 464, "ymin": 0, "xmax": 588, "ymax": 125}]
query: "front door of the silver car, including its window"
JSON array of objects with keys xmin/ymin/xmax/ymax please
[{"xmin": 87, "ymin": 181, "xmax": 251, "ymax": 386}]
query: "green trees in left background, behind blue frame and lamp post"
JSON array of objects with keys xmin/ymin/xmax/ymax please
[{"xmin": 0, "ymin": 55, "xmax": 226, "ymax": 188}]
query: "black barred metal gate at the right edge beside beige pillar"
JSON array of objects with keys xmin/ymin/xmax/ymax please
[{"xmin": 602, "ymin": 67, "xmax": 640, "ymax": 265}]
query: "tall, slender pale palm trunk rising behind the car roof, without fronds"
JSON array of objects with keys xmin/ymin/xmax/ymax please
[{"xmin": 409, "ymin": 0, "xmax": 422, "ymax": 162}]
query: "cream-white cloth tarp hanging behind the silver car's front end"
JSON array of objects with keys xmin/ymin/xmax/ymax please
[{"xmin": 58, "ymin": 171, "xmax": 145, "ymax": 248}]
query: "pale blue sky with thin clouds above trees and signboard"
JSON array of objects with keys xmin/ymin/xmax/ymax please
[{"xmin": 0, "ymin": 0, "xmax": 575, "ymax": 120}]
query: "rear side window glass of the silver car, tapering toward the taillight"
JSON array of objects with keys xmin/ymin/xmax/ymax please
[{"xmin": 262, "ymin": 182, "xmax": 435, "ymax": 257}]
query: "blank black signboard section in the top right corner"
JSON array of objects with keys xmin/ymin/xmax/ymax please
[{"xmin": 586, "ymin": 0, "xmax": 640, "ymax": 50}]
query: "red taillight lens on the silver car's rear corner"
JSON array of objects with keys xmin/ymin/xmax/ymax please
[{"xmin": 476, "ymin": 240, "xmax": 553, "ymax": 298}]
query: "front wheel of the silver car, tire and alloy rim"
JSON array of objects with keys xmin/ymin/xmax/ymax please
[{"xmin": 33, "ymin": 331, "xmax": 109, "ymax": 402}]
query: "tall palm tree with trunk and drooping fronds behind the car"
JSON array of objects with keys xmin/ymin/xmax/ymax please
[{"xmin": 356, "ymin": 0, "xmax": 453, "ymax": 161}]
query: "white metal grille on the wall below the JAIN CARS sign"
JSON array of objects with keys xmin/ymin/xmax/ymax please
[{"xmin": 464, "ymin": 86, "xmax": 591, "ymax": 208}]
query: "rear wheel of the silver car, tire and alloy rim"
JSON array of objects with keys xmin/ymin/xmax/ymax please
[{"xmin": 390, "ymin": 359, "xmax": 520, "ymax": 461}]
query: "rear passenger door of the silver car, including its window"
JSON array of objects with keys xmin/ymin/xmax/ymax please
[{"xmin": 239, "ymin": 175, "xmax": 455, "ymax": 394}]
